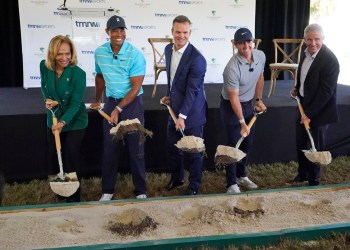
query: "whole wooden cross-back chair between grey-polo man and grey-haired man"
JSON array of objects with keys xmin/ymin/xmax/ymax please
[{"xmin": 267, "ymin": 39, "xmax": 304, "ymax": 97}]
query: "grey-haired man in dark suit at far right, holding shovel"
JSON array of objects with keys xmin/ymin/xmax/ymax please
[{"xmin": 290, "ymin": 24, "xmax": 339, "ymax": 186}]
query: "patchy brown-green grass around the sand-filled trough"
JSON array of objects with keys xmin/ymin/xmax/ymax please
[{"xmin": 2, "ymin": 156, "xmax": 350, "ymax": 250}]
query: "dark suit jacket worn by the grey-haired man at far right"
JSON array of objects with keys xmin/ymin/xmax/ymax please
[{"xmin": 296, "ymin": 44, "xmax": 339, "ymax": 127}]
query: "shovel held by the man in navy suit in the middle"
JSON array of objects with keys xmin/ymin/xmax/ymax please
[{"xmin": 160, "ymin": 100, "xmax": 205, "ymax": 153}]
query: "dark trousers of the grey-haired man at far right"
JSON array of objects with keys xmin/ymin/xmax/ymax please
[{"xmin": 296, "ymin": 117, "xmax": 329, "ymax": 185}]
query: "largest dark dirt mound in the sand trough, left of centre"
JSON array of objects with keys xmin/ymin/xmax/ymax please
[{"xmin": 109, "ymin": 208, "xmax": 158, "ymax": 236}]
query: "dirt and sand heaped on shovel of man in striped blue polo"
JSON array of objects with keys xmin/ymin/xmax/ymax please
[{"xmin": 109, "ymin": 118, "xmax": 153, "ymax": 142}]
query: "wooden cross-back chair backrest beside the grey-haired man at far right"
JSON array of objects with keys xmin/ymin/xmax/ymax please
[{"xmin": 272, "ymin": 38, "xmax": 304, "ymax": 64}]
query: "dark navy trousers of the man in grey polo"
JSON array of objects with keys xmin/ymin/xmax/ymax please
[{"xmin": 220, "ymin": 98, "xmax": 255, "ymax": 187}]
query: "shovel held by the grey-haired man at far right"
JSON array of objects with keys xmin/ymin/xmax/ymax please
[{"xmin": 291, "ymin": 95, "xmax": 332, "ymax": 165}]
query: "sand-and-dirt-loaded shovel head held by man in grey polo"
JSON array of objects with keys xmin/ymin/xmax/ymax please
[{"xmin": 215, "ymin": 145, "xmax": 246, "ymax": 166}]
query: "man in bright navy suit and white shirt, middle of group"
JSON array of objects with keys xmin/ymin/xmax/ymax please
[{"xmin": 161, "ymin": 15, "xmax": 207, "ymax": 195}]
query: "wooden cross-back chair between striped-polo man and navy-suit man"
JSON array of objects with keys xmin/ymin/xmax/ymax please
[{"xmin": 148, "ymin": 38, "xmax": 173, "ymax": 97}]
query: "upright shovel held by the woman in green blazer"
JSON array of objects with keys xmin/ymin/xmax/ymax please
[{"xmin": 47, "ymin": 101, "xmax": 80, "ymax": 197}]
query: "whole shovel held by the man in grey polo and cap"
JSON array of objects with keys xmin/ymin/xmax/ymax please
[{"xmin": 214, "ymin": 111, "xmax": 264, "ymax": 166}]
